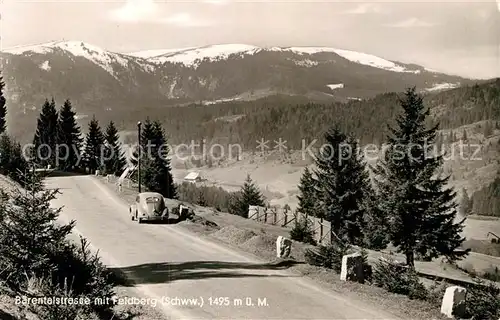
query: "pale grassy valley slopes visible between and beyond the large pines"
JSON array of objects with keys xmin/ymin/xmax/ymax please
[{"xmin": 169, "ymin": 122, "xmax": 500, "ymax": 240}]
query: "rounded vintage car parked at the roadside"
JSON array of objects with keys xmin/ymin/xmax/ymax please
[{"xmin": 129, "ymin": 192, "xmax": 168, "ymax": 223}]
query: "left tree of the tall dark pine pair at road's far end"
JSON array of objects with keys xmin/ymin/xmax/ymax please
[{"xmin": 33, "ymin": 99, "xmax": 58, "ymax": 167}]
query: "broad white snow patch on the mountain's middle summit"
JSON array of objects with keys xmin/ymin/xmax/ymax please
[{"xmin": 150, "ymin": 44, "xmax": 262, "ymax": 68}]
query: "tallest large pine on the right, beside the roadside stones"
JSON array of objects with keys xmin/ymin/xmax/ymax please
[{"xmin": 375, "ymin": 88, "xmax": 466, "ymax": 267}]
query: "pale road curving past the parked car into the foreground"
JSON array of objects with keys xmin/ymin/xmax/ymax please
[{"xmin": 46, "ymin": 176, "xmax": 396, "ymax": 319}]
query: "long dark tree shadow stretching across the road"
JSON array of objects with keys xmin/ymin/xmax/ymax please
[{"xmin": 110, "ymin": 260, "xmax": 301, "ymax": 286}]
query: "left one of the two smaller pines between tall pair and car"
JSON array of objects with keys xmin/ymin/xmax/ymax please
[{"xmin": 84, "ymin": 116, "xmax": 105, "ymax": 173}]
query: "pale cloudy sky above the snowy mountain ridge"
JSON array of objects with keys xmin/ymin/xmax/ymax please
[{"xmin": 1, "ymin": 0, "xmax": 500, "ymax": 78}]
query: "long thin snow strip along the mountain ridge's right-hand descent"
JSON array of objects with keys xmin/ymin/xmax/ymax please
[{"xmin": 282, "ymin": 47, "xmax": 419, "ymax": 73}]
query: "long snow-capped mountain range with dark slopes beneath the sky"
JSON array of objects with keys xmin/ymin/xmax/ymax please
[{"xmin": 0, "ymin": 41, "xmax": 469, "ymax": 141}]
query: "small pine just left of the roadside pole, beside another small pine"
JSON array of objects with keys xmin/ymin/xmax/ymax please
[{"xmin": 104, "ymin": 121, "xmax": 127, "ymax": 176}]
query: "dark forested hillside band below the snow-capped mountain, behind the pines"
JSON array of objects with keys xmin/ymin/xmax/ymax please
[{"xmin": 120, "ymin": 79, "xmax": 500, "ymax": 150}]
